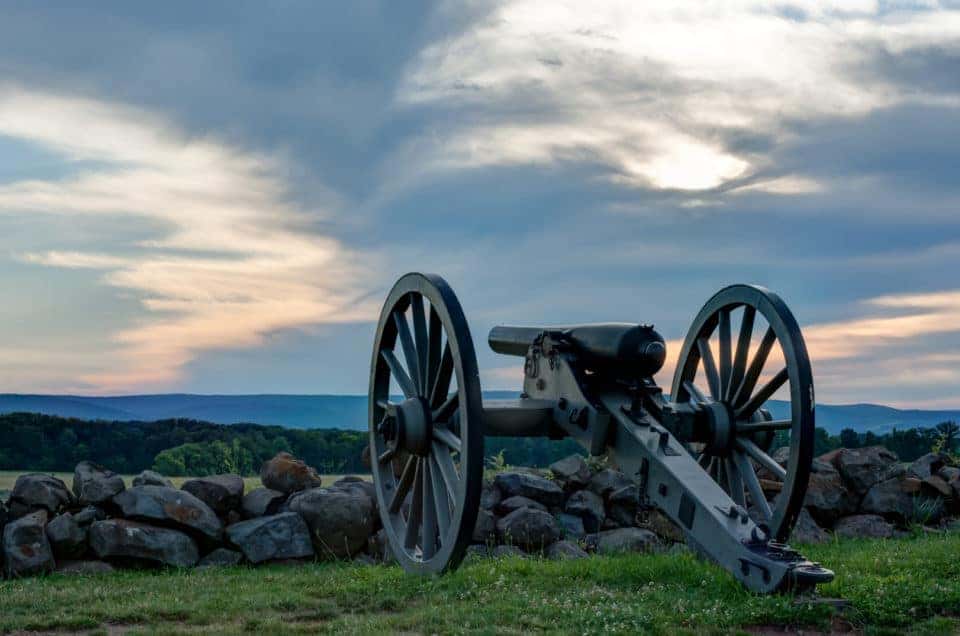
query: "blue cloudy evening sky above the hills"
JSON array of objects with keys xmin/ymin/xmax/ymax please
[{"xmin": 0, "ymin": 0, "xmax": 960, "ymax": 408}]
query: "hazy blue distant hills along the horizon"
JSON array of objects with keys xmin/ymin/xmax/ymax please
[{"xmin": 0, "ymin": 391, "xmax": 960, "ymax": 434}]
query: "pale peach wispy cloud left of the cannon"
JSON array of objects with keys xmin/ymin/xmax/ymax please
[{"xmin": 0, "ymin": 86, "xmax": 375, "ymax": 392}]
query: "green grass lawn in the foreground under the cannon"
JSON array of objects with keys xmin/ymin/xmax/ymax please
[{"xmin": 0, "ymin": 534, "xmax": 960, "ymax": 634}]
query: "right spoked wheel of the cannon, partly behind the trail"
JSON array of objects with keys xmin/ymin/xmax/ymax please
[{"xmin": 672, "ymin": 285, "xmax": 814, "ymax": 541}]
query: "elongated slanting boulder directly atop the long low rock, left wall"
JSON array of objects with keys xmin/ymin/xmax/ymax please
[{"xmin": 113, "ymin": 486, "xmax": 223, "ymax": 541}]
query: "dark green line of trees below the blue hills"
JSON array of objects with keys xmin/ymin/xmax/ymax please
[{"xmin": 0, "ymin": 413, "xmax": 960, "ymax": 477}]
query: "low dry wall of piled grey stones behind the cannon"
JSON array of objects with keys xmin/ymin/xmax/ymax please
[{"xmin": 0, "ymin": 447, "xmax": 960, "ymax": 577}]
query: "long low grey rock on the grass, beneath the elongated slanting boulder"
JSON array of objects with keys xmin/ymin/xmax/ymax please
[{"xmin": 90, "ymin": 520, "xmax": 200, "ymax": 568}]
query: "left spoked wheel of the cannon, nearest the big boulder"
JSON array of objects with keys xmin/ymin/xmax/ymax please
[{"xmin": 369, "ymin": 273, "xmax": 483, "ymax": 574}]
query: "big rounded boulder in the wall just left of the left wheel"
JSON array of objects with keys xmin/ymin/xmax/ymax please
[{"xmin": 287, "ymin": 488, "xmax": 375, "ymax": 558}]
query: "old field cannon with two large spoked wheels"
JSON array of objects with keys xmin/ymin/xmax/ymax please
[{"xmin": 369, "ymin": 273, "xmax": 833, "ymax": 593}]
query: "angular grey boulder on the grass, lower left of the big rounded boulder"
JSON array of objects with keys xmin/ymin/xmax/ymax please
[{"xmin": 227, "ymin": 512, "xmax": 313, "ymax": 563}]
